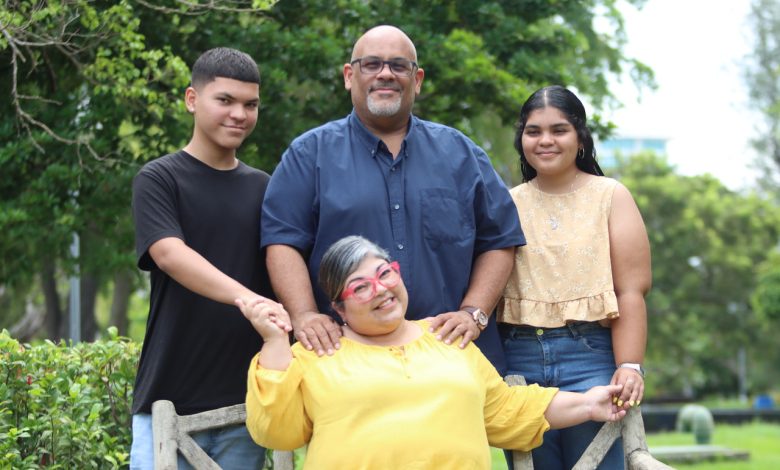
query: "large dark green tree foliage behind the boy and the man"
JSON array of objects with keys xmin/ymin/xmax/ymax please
[{"xmin": 0, "ymin": 0, "xmax": 651, "ymax": 334}]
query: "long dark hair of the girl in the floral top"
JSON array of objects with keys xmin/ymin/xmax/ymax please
[{"xmin": 515, "ymin": 85, "xmax": 604, "ymax": 182}]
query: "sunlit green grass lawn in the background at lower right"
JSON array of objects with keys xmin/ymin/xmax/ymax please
[{"xmin": 491, "ymin": 422, "xmax": 780, "ymax": 470}]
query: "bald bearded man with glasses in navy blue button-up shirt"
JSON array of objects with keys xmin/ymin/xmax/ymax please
[{"xmin": 261, "ymin": 26, "xmax": 525, "ymax": 372}]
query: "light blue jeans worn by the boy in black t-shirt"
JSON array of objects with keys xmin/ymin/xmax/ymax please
[{"xmin": 130, "ymin": 413, "xmax": 265, "ymax": 470}]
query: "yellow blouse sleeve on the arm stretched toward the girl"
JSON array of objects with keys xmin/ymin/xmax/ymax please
[{"xmin": 474, "ymin": 348, "xmax": 558, "ymax": 451}]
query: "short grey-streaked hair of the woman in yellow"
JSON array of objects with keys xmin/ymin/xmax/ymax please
[{"xmin": 319, "ymin": 235, "xmax": 390, "ymax": 302}]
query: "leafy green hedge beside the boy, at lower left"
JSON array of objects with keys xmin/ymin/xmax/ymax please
[{"xmin": 0, "ymin": 328, "xmax": 140, "ymax": 469}]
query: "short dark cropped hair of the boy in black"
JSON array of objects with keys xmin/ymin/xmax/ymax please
[{"xmin": 192, "ymin": 47, "xmax": 260, "ymax": 88}]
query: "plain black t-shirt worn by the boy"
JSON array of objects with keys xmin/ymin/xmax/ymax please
[{"xmin": 133, "ymin": 151, "xmax": 273, "ymax": 414}]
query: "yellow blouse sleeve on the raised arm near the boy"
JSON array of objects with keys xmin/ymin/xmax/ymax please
[{"xmin": 246, "ymin": 353, "xmax": 312, "ymax": 450}]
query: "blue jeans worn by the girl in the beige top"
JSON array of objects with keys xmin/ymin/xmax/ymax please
[{"xmin": 499, "ymin": 322, "xmax": 624, "ymax": 470}]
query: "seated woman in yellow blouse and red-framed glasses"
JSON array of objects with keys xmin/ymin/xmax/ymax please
[{"xmin": 236, "ymin": 237, "xmax": 625, "ymax": 470}]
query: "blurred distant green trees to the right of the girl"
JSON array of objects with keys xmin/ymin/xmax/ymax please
[{"xmin": 617, "ymin": 154, "xmax": 780, "ymax": 396}]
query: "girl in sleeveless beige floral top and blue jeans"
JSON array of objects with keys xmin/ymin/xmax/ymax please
[{"xmin": 497, "ymin": 86, "xmax": 651, "ymax": 470}]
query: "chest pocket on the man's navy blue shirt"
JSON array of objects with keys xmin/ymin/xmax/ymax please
[{"xmin": 420, "ymin": 188, "xmax": 474, "ymax": 245}]
